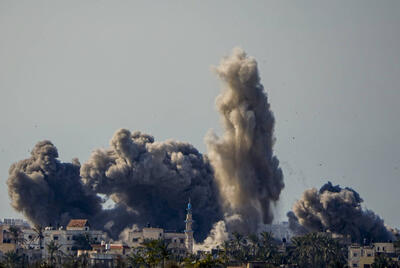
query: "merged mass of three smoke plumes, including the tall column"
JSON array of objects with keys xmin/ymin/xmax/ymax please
[{"xmin": 7, "ymin": 49, "xmax": 284, "ymax": 244}]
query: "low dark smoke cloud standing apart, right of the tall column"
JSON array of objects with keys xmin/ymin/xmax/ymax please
[{"xmin": 289, "ymin": 182, "xmax": 394, "ymax": 242}]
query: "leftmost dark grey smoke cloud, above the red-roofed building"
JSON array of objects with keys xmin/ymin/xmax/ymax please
[{"xmin": 7, "ymin": 141, "xmax": 101, "ymax": 226}]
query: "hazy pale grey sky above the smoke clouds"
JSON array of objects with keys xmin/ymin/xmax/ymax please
[{"xmin": 0, "ymin": 0, "xmax": 400, "ymax": 227}]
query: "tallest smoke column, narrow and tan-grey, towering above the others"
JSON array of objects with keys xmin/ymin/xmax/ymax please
[{"xmin": 206, "ymin": 48, "xmax": 284, "ymax": 233}]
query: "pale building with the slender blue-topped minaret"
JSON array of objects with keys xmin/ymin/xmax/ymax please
[{"xmin": 128, "ymin": 200, "xmax": 194, "ymax": 255}]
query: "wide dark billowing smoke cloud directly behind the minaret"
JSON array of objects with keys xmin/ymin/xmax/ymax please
[{"xmin": 81, "ymin": 129, "xmax": 222, "ymax": 240}]
